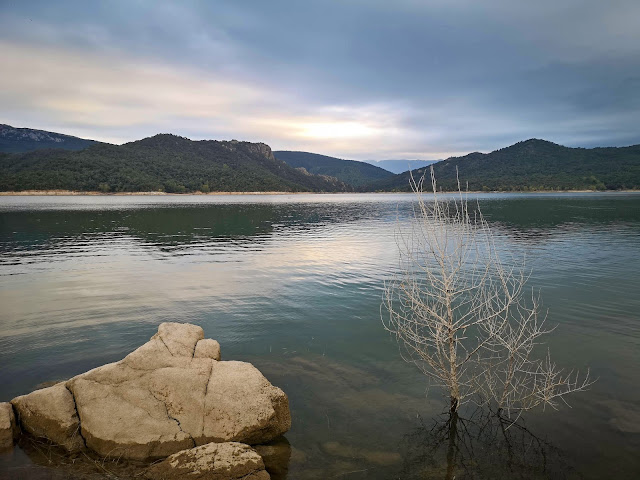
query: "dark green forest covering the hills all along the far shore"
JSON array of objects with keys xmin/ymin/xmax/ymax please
[{"xmin": 0, "ymin": 132, "xmax": 640, "ymax": 193}]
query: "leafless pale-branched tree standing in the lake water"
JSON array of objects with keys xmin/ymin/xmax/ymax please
[{"xmin": 381, "ymin": 169, "xmax": 592, "ymax": 415}]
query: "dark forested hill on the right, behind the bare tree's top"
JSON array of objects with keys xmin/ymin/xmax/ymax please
[{"xmin": 361, "ymin": 139, "xmax": 640, "ymax": 191}]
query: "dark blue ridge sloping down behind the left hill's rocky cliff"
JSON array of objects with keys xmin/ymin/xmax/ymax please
[{"xmin": 273, "ymin": 151, "xmax": 392, "ymax": 187}]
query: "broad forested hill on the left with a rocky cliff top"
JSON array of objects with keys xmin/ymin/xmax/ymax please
[{"xmin": 0, "ymin": 134, "xmax": 352, "ymax": 193}]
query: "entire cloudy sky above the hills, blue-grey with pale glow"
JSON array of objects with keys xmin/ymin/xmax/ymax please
[{"xmin": 0, "ymin": 0, "xmax": 640, "ymax": 160}]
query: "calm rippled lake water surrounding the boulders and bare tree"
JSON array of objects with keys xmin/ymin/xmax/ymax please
[{"xmin": 0, "ymin": 193, "xmax": 640, "ymax": 479}]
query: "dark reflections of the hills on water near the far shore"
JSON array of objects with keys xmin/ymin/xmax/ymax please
[{"xmin": 0, "ymin": 195, "xmax": 639, "ymax": 265}]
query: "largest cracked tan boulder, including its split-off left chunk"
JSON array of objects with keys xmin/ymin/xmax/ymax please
[{"xmin": 20, "ymin": 323, "xmax": 291, "ymax": 460}]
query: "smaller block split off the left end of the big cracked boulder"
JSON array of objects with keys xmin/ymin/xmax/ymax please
[{"xmin": 11, "ymin": 383, "xmax": 85, "ymax": 452}]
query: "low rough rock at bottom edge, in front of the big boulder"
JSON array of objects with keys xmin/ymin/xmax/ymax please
[{"xmin": 145, "ymin": 442, "xmax": 270, "ymax": 480}]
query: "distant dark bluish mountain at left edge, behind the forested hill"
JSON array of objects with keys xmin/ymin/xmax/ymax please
[{"xmin": 0, "ymin": 124, "xmax": 96, "ymax": 153}]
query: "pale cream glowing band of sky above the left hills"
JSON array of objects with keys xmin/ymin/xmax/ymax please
[{"xmin": 0, "ymin": 43, "xmax": 428, "ymax": 158}]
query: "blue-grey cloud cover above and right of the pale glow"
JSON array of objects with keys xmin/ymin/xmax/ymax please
[{"xmin": 0, "ymin": 0, "xmax": 640, "ymax": 158}]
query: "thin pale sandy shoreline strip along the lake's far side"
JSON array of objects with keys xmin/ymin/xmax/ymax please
[{"xmin": 0, "ymin": 190, "xmax": 640, "ymax": 197}]
